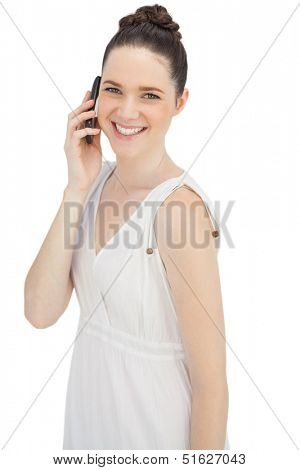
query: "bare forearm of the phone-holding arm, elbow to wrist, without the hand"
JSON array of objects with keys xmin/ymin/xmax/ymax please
[{"xmin": 24, "ymin": 188, "xmax": 85, "ymax": 328}]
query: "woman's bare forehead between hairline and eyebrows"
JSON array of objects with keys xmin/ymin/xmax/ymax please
[{"xmin": 102, "ymin": 46, "xmax": 170, "ymax": 88}]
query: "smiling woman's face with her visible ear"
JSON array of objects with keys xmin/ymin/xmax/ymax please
[{"xmin": 96, "ymin": 47, "xmax": 188, "ymax": 156}]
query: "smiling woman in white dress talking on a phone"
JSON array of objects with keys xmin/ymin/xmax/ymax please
[{"xmin": 25, "ymin": 5, "xmax": 229, "ymax": 449}]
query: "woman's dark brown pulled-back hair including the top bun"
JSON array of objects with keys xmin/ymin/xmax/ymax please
[{"xmin": 102, "ymin": 4, "xmax": 187, "ymax": 103}]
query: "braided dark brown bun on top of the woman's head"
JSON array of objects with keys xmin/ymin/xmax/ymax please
[{"xmin": 119, "ymin": 4, "xmax": 182, "ymax": 39}]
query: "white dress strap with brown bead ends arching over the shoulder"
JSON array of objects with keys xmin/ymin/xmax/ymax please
[{"xmin": 144, "ymin": 175, "xmax": 220, "ymax": 254}]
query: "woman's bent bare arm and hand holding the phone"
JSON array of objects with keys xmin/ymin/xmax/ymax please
[{"xmin": 24, "ymin": 91, "xmax": 102, "ymax": 328}]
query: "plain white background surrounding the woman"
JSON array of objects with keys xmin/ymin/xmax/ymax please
[{"xmin": 0, "ymin": 0, "xmax": 300, "ymax": 468}]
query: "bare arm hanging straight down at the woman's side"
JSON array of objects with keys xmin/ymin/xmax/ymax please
[{"xmin": 155, "ymin": 186, "xmax": 229, "ymax": 449}]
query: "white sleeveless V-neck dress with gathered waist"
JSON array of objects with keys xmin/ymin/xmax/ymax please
[{"xmin": 63, "ymin": 161, "xmax": 230, "ymax": 450}]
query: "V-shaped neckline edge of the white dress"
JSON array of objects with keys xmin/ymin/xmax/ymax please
[{"xmin": 92, "ymin": 162, "xmax": 185, "ymax": 263}]
